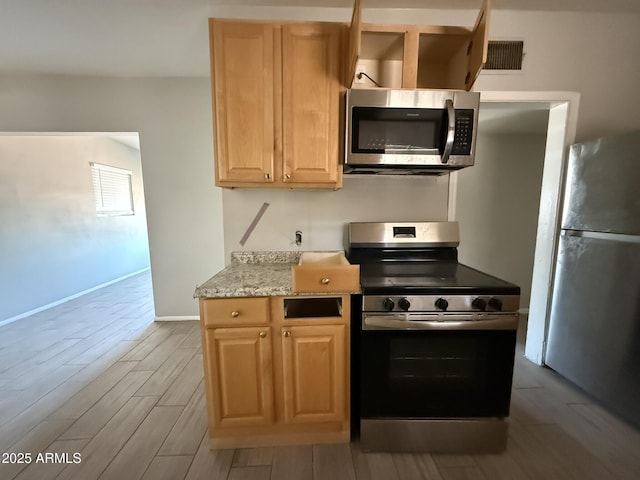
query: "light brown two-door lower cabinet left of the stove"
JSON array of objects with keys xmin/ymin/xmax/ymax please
[{"xmin": 200, "ymin": 295, "xmax": 350, "ymax": 448}]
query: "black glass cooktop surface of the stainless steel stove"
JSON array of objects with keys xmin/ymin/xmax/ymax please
[{"xmin": 360, "ymin": 261, "xmax": 520, "ymax": 295}]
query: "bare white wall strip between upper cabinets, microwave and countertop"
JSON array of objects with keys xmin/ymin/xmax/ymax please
[{"xmin": 223, "ymin": 176, "xmax": 449, "ymax": 259}]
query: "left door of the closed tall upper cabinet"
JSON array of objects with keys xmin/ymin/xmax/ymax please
[{"xmin": 209, "ymin": 19, "xmax": 275, "ymax": 186}]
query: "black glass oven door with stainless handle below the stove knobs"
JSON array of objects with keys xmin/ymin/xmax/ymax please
[{"xmin": 359, "ymin": 313, "xmax": 517, "ymax": 418}]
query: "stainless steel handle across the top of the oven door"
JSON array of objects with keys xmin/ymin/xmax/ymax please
[{"xmin": 362, "ymin": 313, "xmax": 518, "ymax": 330}]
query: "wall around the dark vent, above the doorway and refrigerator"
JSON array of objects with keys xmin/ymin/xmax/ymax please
[{"xmin": 475, "ymin": 10, "xmax": 640, "ymax": 142}]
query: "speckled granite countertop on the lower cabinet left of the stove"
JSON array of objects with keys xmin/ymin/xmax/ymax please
[{"xmin": 193, "ymin": 251, "xmax": 302, "ymax": 298}]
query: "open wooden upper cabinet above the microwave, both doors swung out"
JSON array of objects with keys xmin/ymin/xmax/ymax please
[{"xmin": 347, "ymin": 0, "xmax": 489, "ymax": 90}]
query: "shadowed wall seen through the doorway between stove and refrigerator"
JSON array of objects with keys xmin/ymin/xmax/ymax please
[{"xmin": 456, "ymin": 134, "xmax": 546, "ymax": 308}]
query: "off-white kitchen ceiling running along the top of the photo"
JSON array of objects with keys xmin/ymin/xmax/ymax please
[{"xmin": 0, "ymin": 0, "xmax": 640, "ymax": 77}]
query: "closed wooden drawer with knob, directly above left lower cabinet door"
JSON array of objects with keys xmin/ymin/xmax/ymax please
[{"xmin": 200, "ymin": 297, "xmax": 269, "ymax": 326}]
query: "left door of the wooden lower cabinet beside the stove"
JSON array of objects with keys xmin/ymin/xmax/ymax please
[{"xmin": 206, "ymin": 327, "xmax": 274, "ymax": 427}]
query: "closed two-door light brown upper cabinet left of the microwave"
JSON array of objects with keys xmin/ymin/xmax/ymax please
[{"xmin": 209, "ymin": 18, "xmax": 346, "ymax": 189}]
